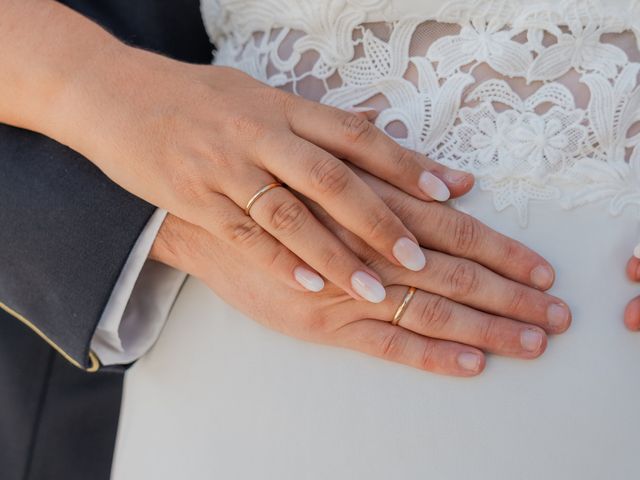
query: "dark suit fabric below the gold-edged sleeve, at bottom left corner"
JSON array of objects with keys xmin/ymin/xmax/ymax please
[{"xmin": 0, "ymin": 313, "xmax": 123, "ymax": 480}]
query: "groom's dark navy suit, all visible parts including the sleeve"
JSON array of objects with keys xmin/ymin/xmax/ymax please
[{"xmin": 0, "ymin": 0, "xmax": 211, "ymax": 480}]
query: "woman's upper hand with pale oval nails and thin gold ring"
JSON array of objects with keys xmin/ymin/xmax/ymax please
[{"xmin": 42, "ymin": 38, "xmax": 473, "ymax": 302}]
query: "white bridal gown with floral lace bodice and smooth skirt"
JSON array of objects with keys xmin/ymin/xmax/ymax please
[{"xmin": 113, "ymin": 0, "xmax": 640, "ymax": 480}]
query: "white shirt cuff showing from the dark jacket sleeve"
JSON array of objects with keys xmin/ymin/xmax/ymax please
[{"xmin": 91, "ymin": 209, "xmax": 186, "ymax": 365}]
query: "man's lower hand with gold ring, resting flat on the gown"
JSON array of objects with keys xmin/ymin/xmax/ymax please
[{"xmin": 152, "ymin": 190, "xmax": 571, "ymax": 376}]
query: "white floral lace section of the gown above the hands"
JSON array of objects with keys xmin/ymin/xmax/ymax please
[{"xmin": 202, "ymin": 0, "xmax": 640, "ymax": 225}]
